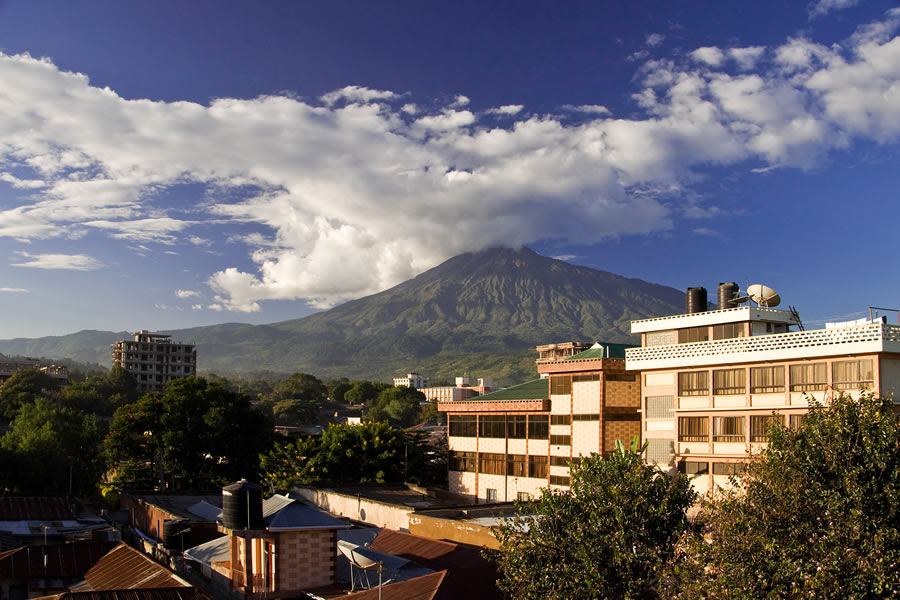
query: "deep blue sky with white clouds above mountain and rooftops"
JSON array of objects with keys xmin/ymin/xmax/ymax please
[{"xmin": 0, "ymin": 0, "xmax": 900, "ymax": 338}]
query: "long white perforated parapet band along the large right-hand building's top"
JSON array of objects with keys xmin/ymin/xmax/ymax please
[{"xmin": 625, "ymin": 323, "xmax": 900, "ymax": 370}]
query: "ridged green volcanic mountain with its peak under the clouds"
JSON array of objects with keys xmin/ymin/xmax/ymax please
[{"xmin": 0, "ymin": 248, "xmax": 684, "ymax": 383}]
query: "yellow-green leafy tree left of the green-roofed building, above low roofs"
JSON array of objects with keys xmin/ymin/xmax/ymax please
[{"xmin": 260, "ymin": 422, "xmax": 416, "ymax": 490}]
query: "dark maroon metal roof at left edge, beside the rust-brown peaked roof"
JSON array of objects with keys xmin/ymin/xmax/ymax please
[{"xmin": 0, "ymin": 542, "xmax": 116, "ymax": 579}]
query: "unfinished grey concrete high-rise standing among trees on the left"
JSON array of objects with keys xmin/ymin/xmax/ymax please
[{"xmin": 112, "ymin": 329, "xmax": 197, "ymax": 393}]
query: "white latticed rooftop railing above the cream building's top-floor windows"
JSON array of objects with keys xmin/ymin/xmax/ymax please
[{"xmin": 625, "ymin": 323, "xmax": 900, "ymax": 369}]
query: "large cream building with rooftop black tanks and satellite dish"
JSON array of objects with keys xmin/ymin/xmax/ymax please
[{"xmin": 626, "ymin": 292, "xmax": 900, "ymax": 493}]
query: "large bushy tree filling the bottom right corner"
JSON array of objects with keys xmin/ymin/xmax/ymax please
[{"xmin": 667, "ymin": 395, "xmax": 900, "ymax": 599}]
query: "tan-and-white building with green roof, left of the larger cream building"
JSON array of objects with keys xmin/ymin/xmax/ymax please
[{"xmin": 438, "ymin": 344, "xmax": 641, "ymax": 502}]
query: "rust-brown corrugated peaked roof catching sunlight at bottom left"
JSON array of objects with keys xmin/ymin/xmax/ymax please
[{"xmin": 72, "ymin": 542, "xmax": 189, "ymax": 592}]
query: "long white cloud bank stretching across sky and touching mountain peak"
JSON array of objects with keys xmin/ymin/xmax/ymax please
[{"xmin": 0, "ymin": 8, "xmax": 900, "ymax": 311}]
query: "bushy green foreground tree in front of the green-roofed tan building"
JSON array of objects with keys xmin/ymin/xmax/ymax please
[{"xmin": 491, "ymin": 441, "xmax": 695, "ymax": 600}]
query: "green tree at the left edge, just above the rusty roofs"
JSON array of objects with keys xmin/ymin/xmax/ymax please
[{"xmin": 0, "ymin": 398, "xmax": 104, "ymax": 494}]
